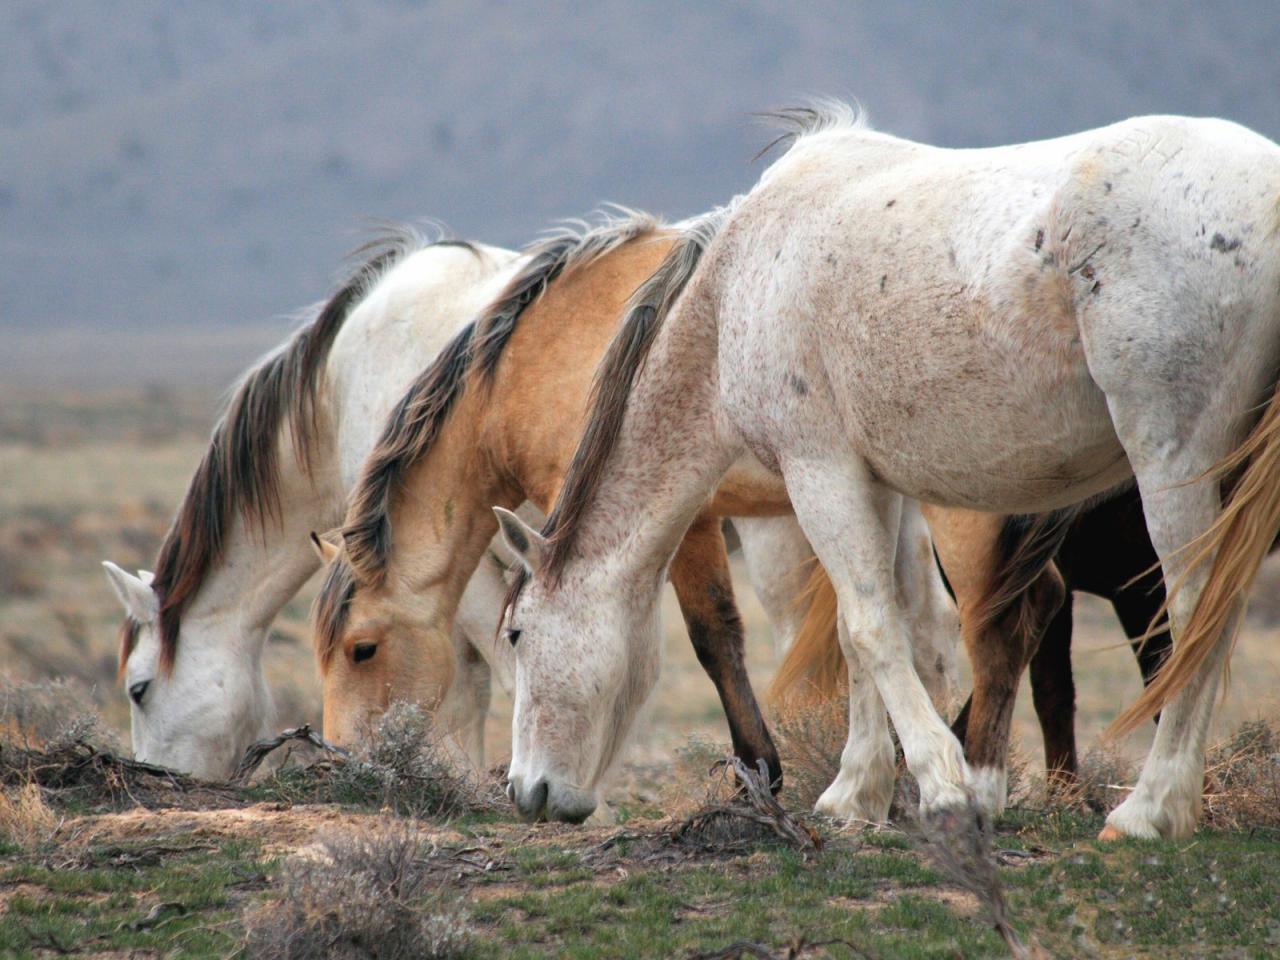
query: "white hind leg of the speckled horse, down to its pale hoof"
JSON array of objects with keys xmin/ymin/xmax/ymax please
[{"xmin": 1089, "ymin": 311, "xmax": 1259, "ymax": 838}]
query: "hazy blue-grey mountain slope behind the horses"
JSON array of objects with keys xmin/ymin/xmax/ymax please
[{"xmin": 0, "ymin": 0, "xmax": 1280, "ymax": 332}]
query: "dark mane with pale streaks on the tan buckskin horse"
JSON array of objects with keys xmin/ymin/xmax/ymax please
[{"xmin": 342, "ymin": 210, "xmax": 659, "ymax": 585}]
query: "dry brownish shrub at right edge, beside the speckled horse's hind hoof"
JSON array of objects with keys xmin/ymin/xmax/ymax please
[{"xmin": 1204, "ymin": 719, "xmax": 1280, "ymax": 829}]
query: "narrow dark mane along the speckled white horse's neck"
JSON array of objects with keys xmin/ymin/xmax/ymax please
[{"xmin": 527, "ymin": 205, "xmax": 732, "ymax": 586}]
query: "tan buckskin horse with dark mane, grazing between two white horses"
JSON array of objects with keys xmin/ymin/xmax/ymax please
[{"xmin": 315, "ymin": 212, "xmax": 951, "ymax": 814}]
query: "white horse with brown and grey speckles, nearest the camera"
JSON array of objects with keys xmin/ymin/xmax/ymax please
[{"xmin": 504, "ymin": 108, "xmax": 1280, "ymax": 837}]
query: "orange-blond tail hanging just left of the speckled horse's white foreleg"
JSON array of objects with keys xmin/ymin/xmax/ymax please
[{"xmin": 769, "ymin": 562, "xmax": 847, "ymax": 707}]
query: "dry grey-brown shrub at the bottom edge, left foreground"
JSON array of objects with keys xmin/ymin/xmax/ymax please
[{"xmin": 244, "ymin": 819, "xmax": 470, "ymax": 960}]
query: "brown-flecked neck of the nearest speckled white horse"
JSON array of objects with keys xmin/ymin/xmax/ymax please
[{"xmin": 552, "ymin": 292, "xmax": 744, "ymax": 591}]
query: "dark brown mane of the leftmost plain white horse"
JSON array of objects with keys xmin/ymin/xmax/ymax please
[{"xmin": 141, "ymin": 230, "xmax": 476, "ymax": 671}]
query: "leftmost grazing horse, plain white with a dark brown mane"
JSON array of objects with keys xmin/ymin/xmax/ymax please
[{"xmin": 96, "ymin": 232, "xmax": 520, "ymax": 778}]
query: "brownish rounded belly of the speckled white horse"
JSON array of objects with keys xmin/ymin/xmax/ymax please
[{"xmin": 833, "ymin": 332, "xmax": 1129, "ymax": 512}]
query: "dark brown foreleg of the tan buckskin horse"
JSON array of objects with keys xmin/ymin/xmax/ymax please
[{"xmin": 669, "ymin": 517, "xmax": 782, "ymax": 792}]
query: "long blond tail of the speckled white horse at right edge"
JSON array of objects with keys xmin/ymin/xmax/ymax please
[{"xmin": 1105, "ymin": 384, "xmax": 1280, "ymax": 737}]
